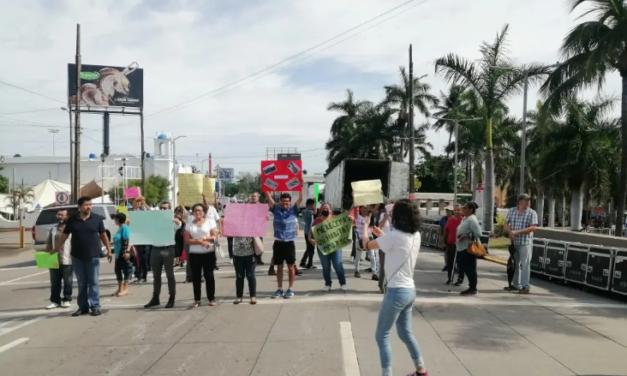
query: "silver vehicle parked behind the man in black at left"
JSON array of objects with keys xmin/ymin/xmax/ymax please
[{"xmin": 31, "ymin": 204, "xmax": 117, "ymax": 254}]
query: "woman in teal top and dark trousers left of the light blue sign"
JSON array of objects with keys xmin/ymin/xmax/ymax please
[{"xmin": 113, "ymin": 213, "xmax": 133, "ymax": 297}]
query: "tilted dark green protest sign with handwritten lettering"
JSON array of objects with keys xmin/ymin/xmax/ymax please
[{"xmin": 311, "ymin": 212, "xmax": 353, "ymax": 255}]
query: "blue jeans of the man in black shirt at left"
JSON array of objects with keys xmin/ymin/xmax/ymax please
[{"xmin": 72, "ymin": 257, "xmax": 100, "ymax": 312}]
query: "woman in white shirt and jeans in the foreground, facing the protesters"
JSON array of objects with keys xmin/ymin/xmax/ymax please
[{"xmin": 361, "ymin": 199, "xmax": 428, "ymax": 376}]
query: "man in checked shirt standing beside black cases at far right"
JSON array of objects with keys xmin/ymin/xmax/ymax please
[{"xmin": 505, "ymin": 194, "xmax": 538, "ymax": 294}]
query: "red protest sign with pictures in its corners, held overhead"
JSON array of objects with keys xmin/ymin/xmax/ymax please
[{"xmin": 261, "ymin": 160, "xmax": 303, "ymax": 192}]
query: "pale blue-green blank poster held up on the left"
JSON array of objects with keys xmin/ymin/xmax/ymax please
[{"xmin": 128, "ymin": 210, "xmax": 174, "ymax": 245}]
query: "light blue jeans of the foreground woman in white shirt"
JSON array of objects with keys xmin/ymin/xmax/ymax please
[{"xmin": 375, "ymin": 287, "xmax": 424, "ymax": 376}]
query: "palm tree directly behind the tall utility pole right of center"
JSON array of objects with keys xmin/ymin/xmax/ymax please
[{"xmin": 383, "ymin": 67, "xmax": 439, "ymax": 162}]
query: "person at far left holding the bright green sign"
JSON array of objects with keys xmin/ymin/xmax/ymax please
[{"xmin": 46, "ymin": 209, "xmax": 72, "ymax": 309}]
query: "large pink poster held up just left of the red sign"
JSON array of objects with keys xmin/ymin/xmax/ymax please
[{"xmin": 224, "ymin": 204, "xmax": 268, "ymax": 238}]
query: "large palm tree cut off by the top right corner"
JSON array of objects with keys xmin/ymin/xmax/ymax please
[{"xmin": 542, "ymin": 0, "xmax": 627, "ymax": 234}]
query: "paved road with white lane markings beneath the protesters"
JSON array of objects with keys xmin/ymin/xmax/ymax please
[{"xmin": 0, "ymin": 235, "xmax": 627, "ymax": 376}]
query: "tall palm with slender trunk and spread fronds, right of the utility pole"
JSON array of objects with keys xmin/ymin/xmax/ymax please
[{"xmin": 435, "ymin": 25, "xmax": 548, "ymax": 231}]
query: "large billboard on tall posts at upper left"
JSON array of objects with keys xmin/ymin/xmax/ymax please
[{"xmin": 67, "ymin": 63, "xmax": 144, "ymax": 108}]
